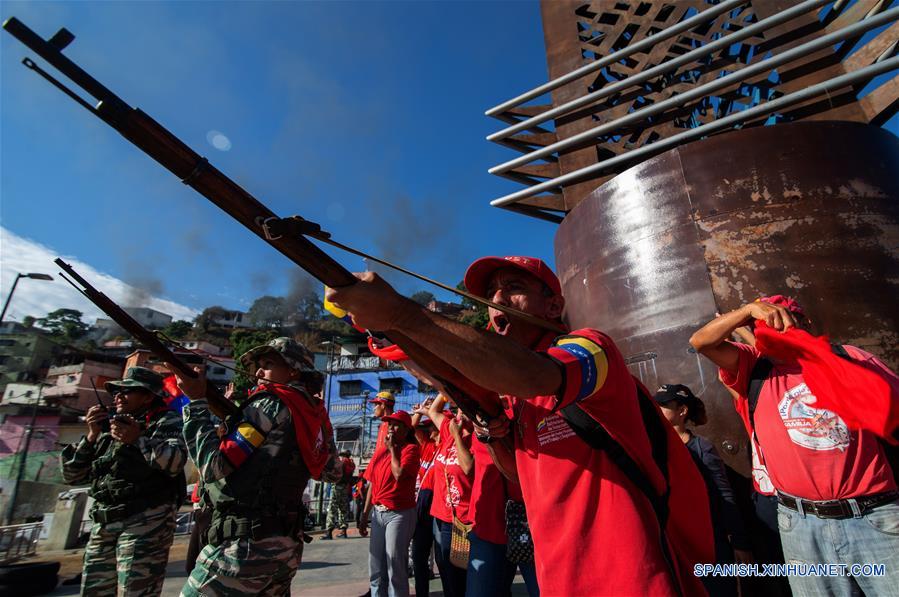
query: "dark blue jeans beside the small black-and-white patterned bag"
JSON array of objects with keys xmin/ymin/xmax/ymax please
[{"xmin": 465, "ymin": 531, "xmax": 540, "ymax": 597}]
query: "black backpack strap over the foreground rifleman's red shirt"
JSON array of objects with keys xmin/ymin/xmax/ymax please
[{"xmin": 559, "ymin": 382, "xmax": 682, "ymax": 595}]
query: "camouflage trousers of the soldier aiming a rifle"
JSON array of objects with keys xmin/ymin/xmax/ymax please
[{"xmin": 181, "ymin": 537, "xmax": 303, "ymax": 597}]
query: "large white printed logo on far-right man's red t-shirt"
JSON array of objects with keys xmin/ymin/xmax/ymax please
[{"xmin": 777, "ymin": 383, "xmax": 850, "ymax": 452}]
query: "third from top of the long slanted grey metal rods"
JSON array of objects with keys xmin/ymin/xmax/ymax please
[{"xmin": 490, "ymin": 7, "xmax": 899, "ymax": 174}]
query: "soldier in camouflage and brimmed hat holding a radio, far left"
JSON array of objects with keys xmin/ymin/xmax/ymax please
[{"xmin": 61, "ymin": 367, "xmax": 187, "ymax": 595}]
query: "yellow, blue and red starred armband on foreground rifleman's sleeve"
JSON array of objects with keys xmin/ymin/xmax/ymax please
[{"xmin": 547, "ymin": 335, "xmax": 609, "ymax": 406}]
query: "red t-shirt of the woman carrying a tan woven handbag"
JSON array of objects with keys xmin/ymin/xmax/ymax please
[{"xmin": 431, "ymin": 416, "xmax": 474, "ymax": 524}]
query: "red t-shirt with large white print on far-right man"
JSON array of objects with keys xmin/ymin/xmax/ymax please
[{"xmin": 720, "ymin": 343, "xmax": 896, "ymax": 501}]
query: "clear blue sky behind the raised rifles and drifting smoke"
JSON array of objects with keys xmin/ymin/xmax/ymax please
[{"xmin": 0, "ymin": 2, "xmax": 554, "ymax": 317}]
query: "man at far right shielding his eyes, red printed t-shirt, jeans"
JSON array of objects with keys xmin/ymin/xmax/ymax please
[{"xmin": 690, "ymin": 295, "xmax": 899, "ymax": 595}]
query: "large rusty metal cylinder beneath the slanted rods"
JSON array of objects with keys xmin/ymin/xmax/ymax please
[{"xmin": 555, "ymin": 121, "xmax": 899, "ymax": 474}]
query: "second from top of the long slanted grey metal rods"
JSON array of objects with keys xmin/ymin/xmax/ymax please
[{"xmin": 487, "ymin": 0, "xmax": 831, "ymax": 144}]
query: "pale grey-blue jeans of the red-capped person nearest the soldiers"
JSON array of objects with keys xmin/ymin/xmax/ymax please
[{"xmin": 368, "ymin": 508, "xmax": 415, "ymax": 597}]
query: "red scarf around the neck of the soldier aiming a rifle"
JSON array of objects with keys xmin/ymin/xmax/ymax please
[{"xmin": 250, "ymin": 383, "xmax": 333, "ymax": 480}]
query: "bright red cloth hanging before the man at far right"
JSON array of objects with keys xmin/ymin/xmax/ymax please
[{"xmin": 755, "ymin": 321, "xmax": 899, "ymax": 444}]
